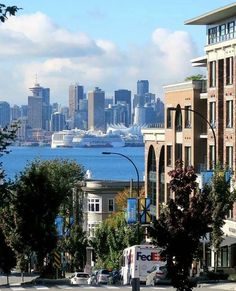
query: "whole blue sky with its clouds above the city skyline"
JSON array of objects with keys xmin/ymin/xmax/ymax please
[{"xmin": 0, "ymin": 0, "xmax": 234, "ymax": 106}]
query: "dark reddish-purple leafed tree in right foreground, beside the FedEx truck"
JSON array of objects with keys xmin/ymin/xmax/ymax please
[{"xmin": 149, "ymin": 161, "xmax": 212, "ymax": 291}]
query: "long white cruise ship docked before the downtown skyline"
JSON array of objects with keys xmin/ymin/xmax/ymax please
[{"xmin": 51, "ymin": 129, "xmax": 125, "ymax": 148}]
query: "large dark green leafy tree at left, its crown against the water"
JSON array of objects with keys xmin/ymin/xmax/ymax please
[{"xmin": 2, "ymin": 160, "xmax": 83, "ymax": 269}]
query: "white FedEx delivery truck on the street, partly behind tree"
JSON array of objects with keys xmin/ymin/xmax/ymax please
[{"xmin": 121, "ymin": 245, "xmax": 161, "ymax": 285}]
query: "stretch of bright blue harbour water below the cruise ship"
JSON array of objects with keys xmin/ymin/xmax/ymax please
[{"xmin": 0, "ymin": 147, "xmax": 144, "ymax": 181}]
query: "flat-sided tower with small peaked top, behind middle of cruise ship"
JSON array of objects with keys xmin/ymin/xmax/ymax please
[{"xmin": 88, "ymin": 87, "xmax": 105, "ymax": 131}]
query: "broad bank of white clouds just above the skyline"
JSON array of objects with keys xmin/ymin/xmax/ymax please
[{"xmin": 0, "ymin": 12, "xmax": 200, "ymax": 105}]
